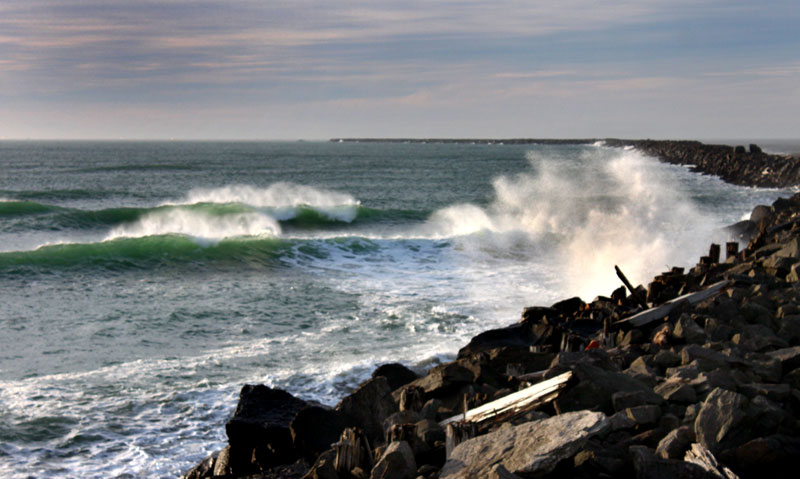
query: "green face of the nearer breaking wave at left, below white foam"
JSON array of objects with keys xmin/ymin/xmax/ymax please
[{"xmin": 0, "ymin": 235, "xmax": 293, "ymax": 272}]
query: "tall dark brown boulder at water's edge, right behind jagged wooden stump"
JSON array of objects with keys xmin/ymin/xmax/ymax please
[{"xmin": 336, "ymin": 376, "xmax": 397, "ymax": 445}]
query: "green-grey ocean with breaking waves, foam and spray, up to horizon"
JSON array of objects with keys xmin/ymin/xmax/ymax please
[{"xmin": 0, "ymin": 141, "xmax": 790, "ymax": 478}]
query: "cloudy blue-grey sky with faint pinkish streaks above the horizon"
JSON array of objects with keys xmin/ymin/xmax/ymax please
[{"xmin": 0, "ymin": 0, "xmax": 800, "ymax": 140}]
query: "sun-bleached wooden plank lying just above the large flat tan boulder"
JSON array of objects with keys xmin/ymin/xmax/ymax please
[{"xmin": 439, "ymin": 371, "xmax": 572, "ymax": 427}]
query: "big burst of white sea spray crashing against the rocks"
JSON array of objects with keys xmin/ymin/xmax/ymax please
[{"xmin": 424, "ymin": 147, "xmax": 716, "ymax": 298}]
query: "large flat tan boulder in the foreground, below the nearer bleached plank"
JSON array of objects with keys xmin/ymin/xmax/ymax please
[{"xmin": 440, "ymin": 411, "xmax": 608, "ymax": 479}]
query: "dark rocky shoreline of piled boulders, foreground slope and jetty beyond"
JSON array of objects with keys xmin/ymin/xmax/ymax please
[{"xmin": 185, "ymin": 140, "xmax": 800, "ymax": 479}]
